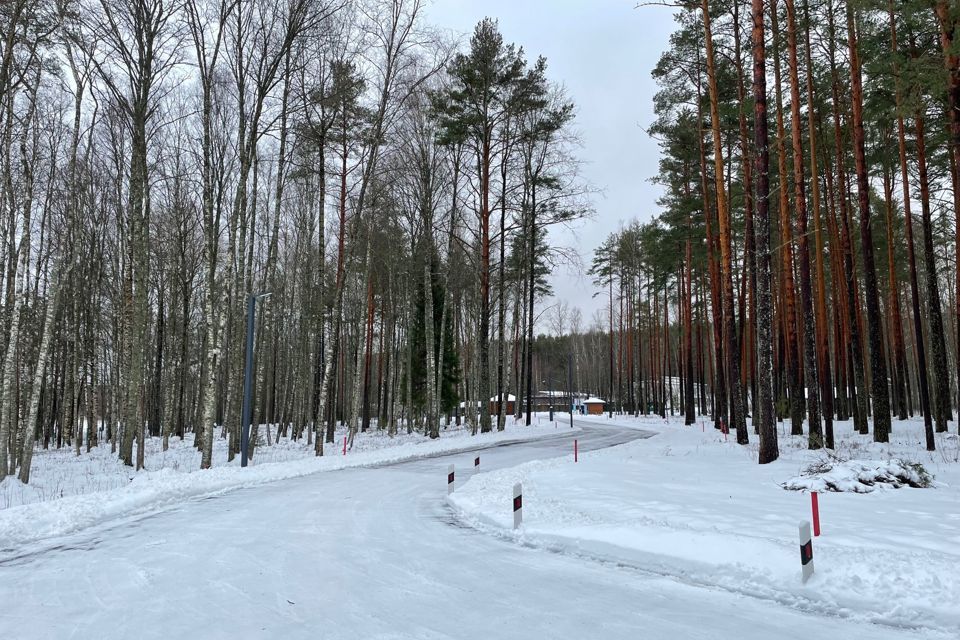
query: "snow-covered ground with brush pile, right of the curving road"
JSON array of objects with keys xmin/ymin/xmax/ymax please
[{"xmin": 449, "ymin": 416, "xmax": 960, "ymax": 637}]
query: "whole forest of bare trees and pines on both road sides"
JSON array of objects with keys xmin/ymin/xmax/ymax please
[{"xmin": 0, "ymin": 0, "xmax": 960, "ymax": 483}]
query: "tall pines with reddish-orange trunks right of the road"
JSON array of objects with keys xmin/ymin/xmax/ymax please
[{"xmin": 591, "ymin": 0, "xmax": 960, "ymax": 463}]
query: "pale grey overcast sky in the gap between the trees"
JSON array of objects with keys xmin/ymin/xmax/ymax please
[{"xmin": 427, "ymin": 0, "xmax": 674, "ymax": 330}]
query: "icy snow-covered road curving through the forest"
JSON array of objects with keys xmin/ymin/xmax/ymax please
[{"xmin": 0, "ymin": 423, "xmax": 936, "ymax": 640}]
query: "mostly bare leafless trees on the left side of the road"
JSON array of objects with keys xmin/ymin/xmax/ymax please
[{"xmin": 0, "ymin": 0, "xmax": 590, "ymax": 482}]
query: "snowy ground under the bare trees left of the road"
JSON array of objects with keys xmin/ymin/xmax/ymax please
[{"xmin": 0, "ymin": 420, "xmax": 569, "ymax": 551}]
